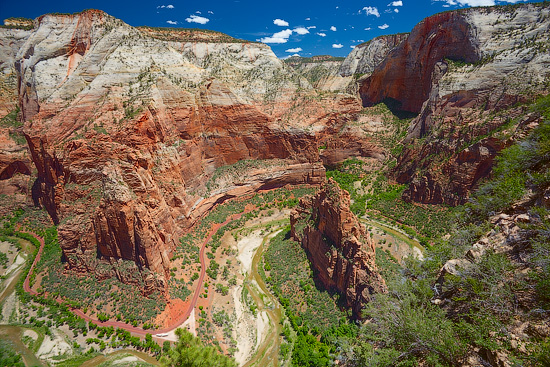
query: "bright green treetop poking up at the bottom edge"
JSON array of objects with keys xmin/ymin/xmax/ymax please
[{"xmin": 160, "ymin": 329, "xmax": 237, "ymax": 367}]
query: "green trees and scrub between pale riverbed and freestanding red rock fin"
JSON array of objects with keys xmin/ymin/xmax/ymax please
[{"xmin": 264, "ymin": 228, "xmax": 358, "ymax": 366}]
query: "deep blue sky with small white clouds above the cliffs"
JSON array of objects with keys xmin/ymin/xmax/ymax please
[{"xmin": 0, "ymin": 0, "xmax": 540, "ymax": 57}]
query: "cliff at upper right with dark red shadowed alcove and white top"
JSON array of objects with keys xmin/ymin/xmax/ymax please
[{"xmin": 360, "ymin": 4, "xmax": 550, "ymax": 205}]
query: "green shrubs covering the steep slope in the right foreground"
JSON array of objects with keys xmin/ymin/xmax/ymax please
[{"xmin": 344, "ymin": 96, "xmax": 550, "ymax": 366}]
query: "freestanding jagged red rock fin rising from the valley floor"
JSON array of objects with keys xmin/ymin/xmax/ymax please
[{"xmin": 290, "ymin": 179, "xmax": 386, "ymax": 318}]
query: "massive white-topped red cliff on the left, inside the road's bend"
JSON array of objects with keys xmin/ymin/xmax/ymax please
[{"xmin": 10, "ymin": 10, "xmax": 376, "ymax": 291}]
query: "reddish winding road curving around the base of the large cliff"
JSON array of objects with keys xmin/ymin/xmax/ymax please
[{"xmin": 23, "ymin": 210, "xmax": 248, "ymax": 340}]
